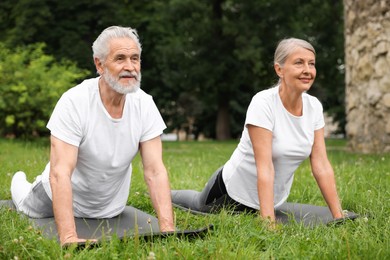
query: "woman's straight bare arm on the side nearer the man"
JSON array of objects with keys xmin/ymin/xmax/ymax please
[{"xmin": 247, "ymin": 125, "xmax": 275, "ymax": 222}]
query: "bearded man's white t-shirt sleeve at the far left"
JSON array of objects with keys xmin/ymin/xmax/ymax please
[{"xmin": 47, "ymin": 93, "xmax": 82, "ymax": 147}]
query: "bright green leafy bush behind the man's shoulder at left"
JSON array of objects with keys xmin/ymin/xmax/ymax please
[{"xmin": 0, "ymin": 43, "xmax": 86, "ymax": 137}]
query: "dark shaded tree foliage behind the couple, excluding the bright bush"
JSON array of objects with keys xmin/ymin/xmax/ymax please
[{"xmin": 0, "ymin": 0, "xmax": 345, "ymax": 139}]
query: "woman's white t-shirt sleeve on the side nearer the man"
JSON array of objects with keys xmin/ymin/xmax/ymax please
[{"xmin": 245, "ymin": 92, "xmax": 275, "ymax": 131}]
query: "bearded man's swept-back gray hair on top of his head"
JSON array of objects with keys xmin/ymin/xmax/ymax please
[{"xmin": 92, "ymin": 26, "xmax": 142, "ymax": 61}]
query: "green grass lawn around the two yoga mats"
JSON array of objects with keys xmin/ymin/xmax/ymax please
[{"xmin": 0, "ymin": 139, "xmax": 390, "ymax": 260}]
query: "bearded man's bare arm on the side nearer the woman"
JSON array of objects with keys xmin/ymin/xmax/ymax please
[{"xmin": 140, "ymin": 137, "xmax": 175, "ymax": 232}]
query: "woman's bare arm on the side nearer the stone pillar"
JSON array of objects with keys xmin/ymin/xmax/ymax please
[{"xmin": 310, "ymin": 128, "xmax": 343, "ymax": 218}]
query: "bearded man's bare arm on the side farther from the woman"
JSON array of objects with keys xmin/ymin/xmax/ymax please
[{"xmin": 50, "ymin": 136, "xmax": 90, "ymax": 245}]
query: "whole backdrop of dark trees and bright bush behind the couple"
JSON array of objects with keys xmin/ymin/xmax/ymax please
[{"xmin": 0, "ymin": 0, "xmax": 345, "ymax": 140}]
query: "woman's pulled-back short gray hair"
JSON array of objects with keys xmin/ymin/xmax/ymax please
[{"xmin": 274, "ymin": 38, "xmax": 316, "ymax": 67}]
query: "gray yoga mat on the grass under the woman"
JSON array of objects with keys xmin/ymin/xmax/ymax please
[{"xmin": 173, "ymin": 202, "xmax": 359, "ymax": 227}]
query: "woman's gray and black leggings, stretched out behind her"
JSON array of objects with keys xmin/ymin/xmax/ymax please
[{"xmin": 171, "ymin": 166, "xmax": 256, "ymax": 213}]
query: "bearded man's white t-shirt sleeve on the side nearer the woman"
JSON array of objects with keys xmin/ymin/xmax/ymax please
[{"xmin": 140, "ymin": 96, "xmax": 166, "ymax": 142}]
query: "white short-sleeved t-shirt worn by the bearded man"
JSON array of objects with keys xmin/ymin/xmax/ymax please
[{"xmin": 42, "ymin": 78, "xmax": 166, "ymax": 218}]
